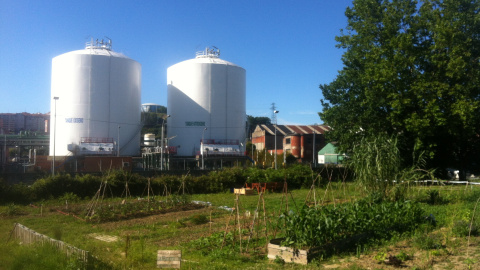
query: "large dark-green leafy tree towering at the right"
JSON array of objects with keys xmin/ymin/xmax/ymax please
[{"xmin": 319, "ymin": 0, "xmax": 480, "ymax": 177}]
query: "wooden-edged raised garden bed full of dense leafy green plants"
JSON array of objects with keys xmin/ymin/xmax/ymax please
[{"xmin": 278, "ymin": 200, "xmax": 434, "ymax": 264}]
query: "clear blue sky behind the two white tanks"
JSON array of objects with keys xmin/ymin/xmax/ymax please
[{"xmin": 0, "ymin": 0, "xmax": 351, "ymax": 125}]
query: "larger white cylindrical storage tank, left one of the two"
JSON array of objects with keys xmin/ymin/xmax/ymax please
[{"xmin": 50, "ymin": 40, "xmax": 142, "ymax": 156}]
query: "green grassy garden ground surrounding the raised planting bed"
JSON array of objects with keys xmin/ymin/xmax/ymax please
[{"xmin": 0, "ymin": 183, "xmax": 480, "ymax": 269}]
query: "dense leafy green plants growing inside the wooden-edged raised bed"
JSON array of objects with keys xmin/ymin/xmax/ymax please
[{"xmin": 279, "ymin": 200, "xmax": 426, "ymax": 248}]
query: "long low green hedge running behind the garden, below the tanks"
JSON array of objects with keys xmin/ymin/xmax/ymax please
[{"xmin": 0, "ymin": 165, "xmax": 322, "ymax": 203}]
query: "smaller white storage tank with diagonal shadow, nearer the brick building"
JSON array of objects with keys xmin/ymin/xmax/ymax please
[{"xmin": 167, "ymin": 48, "xmax": 246, "ymax": 156}]
